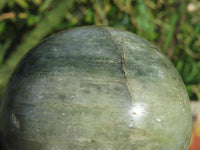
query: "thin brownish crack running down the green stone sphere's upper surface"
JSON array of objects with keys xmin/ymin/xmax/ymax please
[{"xmin": 104, "ymin": 28, "xmax": 134, "ymax": 101}]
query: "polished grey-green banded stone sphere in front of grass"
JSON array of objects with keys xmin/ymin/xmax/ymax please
[{"xmin": 0, "ymin": 26, "xmax": 191, "ymax": 150}]
